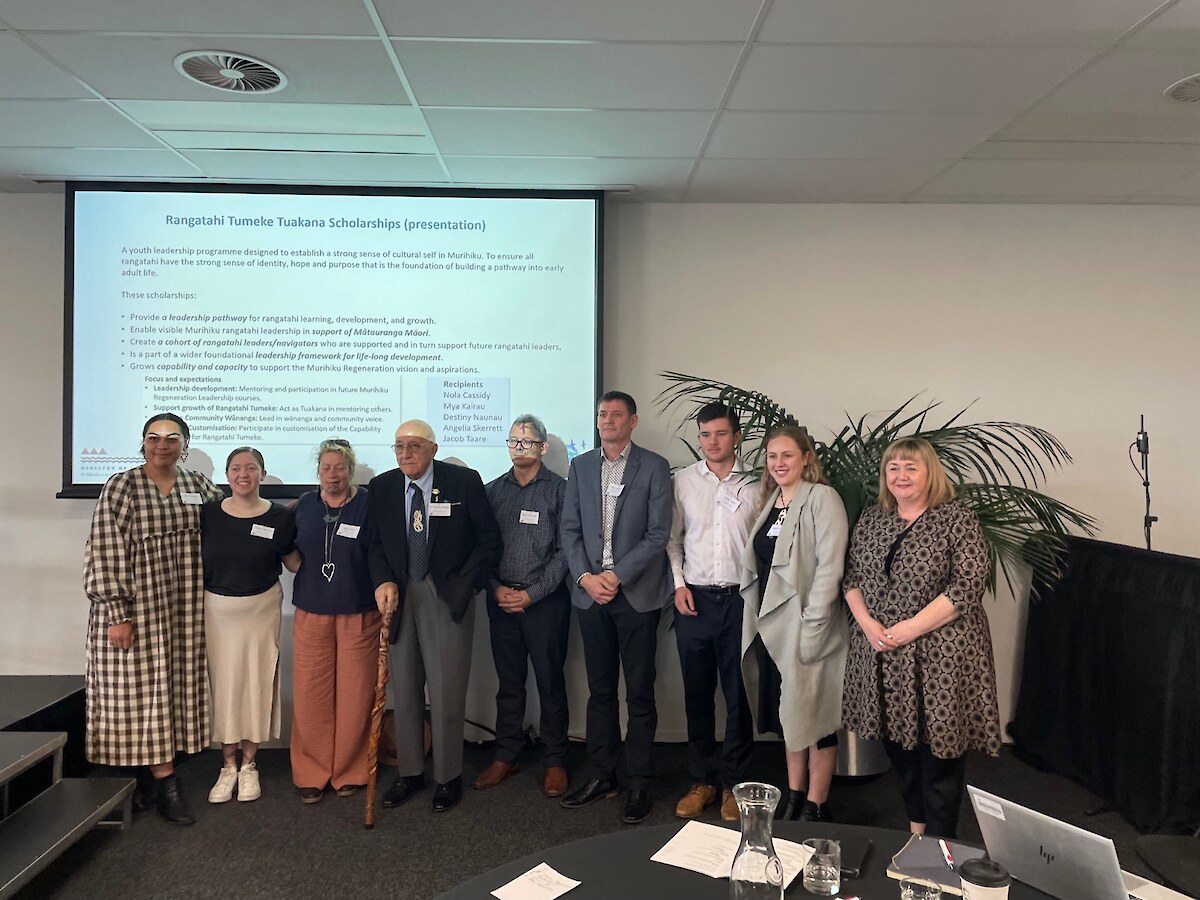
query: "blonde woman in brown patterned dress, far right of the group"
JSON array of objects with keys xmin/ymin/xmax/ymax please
[{"xmin": 842, "ymin": 438, "xmax": 1000, "ymax": 838}]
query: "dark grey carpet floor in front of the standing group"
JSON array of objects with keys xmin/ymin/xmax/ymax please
[{"xmin": 17, "ymin": 744, "xmax": 1151, "ymax": 900}]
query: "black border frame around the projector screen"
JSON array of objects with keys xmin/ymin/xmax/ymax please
[{"xmin": 55, "ymin": 181, "xmax": 605, "ymax": 500}]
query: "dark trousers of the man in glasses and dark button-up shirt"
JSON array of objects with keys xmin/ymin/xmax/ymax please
[{"xmin": 487, "ymin": 588, "xmax": 571, "ymax": 767}]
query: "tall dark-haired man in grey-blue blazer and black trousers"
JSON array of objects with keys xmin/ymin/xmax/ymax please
[{"xmin": 560, "ymin": 391, "xmax": 674, "ymax": 824}]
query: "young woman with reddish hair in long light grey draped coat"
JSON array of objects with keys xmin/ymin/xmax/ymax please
[{"xmin": 742, "ymin": 426, "xmax": 850, "ymax": 822}]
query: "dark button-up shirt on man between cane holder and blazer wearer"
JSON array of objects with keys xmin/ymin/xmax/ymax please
[{"xmin": 487, "ymin": 466, "xmax": 566, "ymax": 602}]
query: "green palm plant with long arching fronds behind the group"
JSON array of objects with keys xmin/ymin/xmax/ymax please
[{"xmin": 655, "ymin": 372, "xmax": 1097, "ymax": 594}]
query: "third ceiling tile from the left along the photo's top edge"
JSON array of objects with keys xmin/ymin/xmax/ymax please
[{"xmin": 758, "ymin": 0, "xmax": 1162, "ymax": 47}]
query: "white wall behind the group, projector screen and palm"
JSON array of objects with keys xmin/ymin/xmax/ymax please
[{"xmin": 0, "ymin": 196, "xmax": 1200, "ymax": 739}]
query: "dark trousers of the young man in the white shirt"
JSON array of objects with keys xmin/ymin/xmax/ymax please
[{"xmin": 674, "ymin": 584, "xmax": 754, "ymax": 788}]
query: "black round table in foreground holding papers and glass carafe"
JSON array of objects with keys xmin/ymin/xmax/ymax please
[{"xmin": 442, "ymin": 822, "xmax": 1048, "ymax": 900}]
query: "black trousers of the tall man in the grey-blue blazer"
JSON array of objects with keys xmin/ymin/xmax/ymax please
[{"xmin": 577, "ymin": 590, "xmax": 662, "ymax": 791}]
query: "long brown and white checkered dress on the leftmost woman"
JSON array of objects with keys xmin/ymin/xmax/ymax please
[{"xmin": 84, "ymin": 466, "xmax": 223, "ymax": 766}]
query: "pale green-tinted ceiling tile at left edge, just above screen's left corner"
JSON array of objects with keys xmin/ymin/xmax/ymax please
[{"xmin": 0, "ymin": 148, "xmax": 200, "ymax": 181}]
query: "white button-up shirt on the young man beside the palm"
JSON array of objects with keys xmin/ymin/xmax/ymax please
[{"xmin": 667, "ymin": 460, "xmax": 761, "ymax": 589}]
